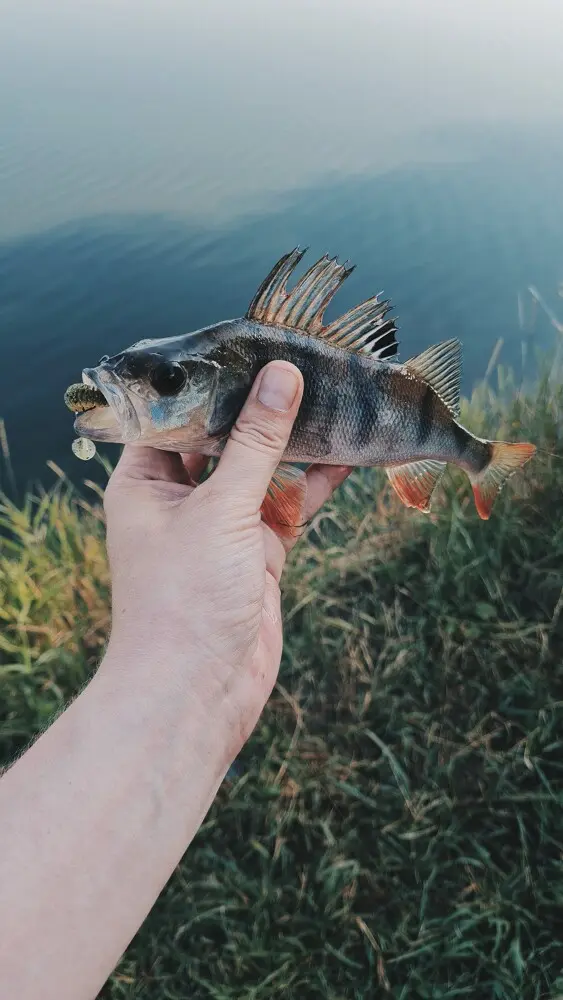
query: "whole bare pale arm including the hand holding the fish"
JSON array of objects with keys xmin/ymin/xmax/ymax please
[{"xmin": 0, "ymin": 363, "xmax": 350, "ymax": 1000}]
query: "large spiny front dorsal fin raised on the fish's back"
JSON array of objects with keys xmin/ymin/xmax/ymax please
[{"xmin": 246, "ymin": 247, "xmax": 397, "ymax": 360}]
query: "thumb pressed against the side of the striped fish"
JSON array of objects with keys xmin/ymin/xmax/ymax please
[{"xmin": 213, "ymin": 361, "xmax": 303, "ymax": 512}]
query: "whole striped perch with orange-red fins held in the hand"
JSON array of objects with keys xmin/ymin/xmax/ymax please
[{"xmin": 66, "ymin": 247, "xmax": 536, "ymax": 535}]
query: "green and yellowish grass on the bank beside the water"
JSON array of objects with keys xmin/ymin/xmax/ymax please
[{"xmin": 0, "ymin": 358, "xmax": 563, "ymax": 1000}]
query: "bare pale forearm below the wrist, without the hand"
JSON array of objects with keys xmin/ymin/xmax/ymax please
[{"xmin": 0, "ymin": 654, "xmax": 230, "ymax": 1000}]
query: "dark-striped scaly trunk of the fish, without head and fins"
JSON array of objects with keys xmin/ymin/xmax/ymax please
[{"xmin": 203, "ymin": 319, "xmax": 489, "ymax": 472}]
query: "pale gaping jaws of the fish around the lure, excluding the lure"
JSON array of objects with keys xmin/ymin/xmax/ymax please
[{"xmin": 74, "ymin": 366, "xmax": 141, "ymax": 444}]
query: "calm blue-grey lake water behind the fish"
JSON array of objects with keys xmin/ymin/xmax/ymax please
[{"xmin": 0, "ymin": 0, "xmax": 563, "ymax": 492}]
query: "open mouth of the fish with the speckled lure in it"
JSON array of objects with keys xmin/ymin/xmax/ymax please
[{"xmin": 65, "ymin": 366, "xmax": 141, "ymax": 443}]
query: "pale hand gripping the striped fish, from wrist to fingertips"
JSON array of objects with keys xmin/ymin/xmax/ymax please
[{"xmin": 105, "ymin": 362, "xmax": 351, "ymax": 762}]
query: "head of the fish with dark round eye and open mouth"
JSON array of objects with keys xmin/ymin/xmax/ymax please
[{"xmin": 74, "ymin": 338, "xmax": 220, "ymax": 450}]
